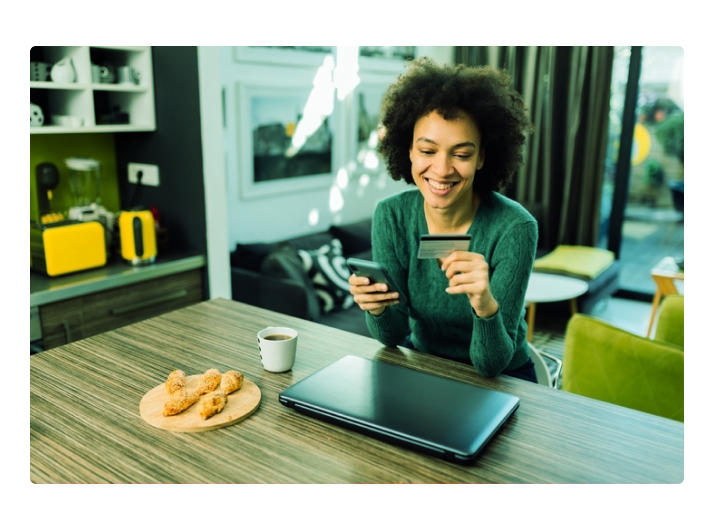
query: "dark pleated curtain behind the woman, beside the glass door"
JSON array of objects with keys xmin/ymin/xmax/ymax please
[{"xmin": 455, "ymin": 46, "xmax": 614, "ymax": 250}]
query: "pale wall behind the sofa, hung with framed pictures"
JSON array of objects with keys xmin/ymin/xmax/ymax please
[{"xmin": 220, "ymin": 46, "xmax": 453, "ymax": 251}]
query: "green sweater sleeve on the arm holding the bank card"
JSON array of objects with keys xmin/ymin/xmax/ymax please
[{"xmin": 469, "ymin": 218, "xmax": 538, "ymax": 377}]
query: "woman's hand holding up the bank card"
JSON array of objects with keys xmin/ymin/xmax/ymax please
[{"xmin": 442, "ymin": 251, "xmax": 499, "ymax": 319}]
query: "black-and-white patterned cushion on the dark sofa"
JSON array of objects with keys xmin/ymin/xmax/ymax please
[{"xmin": 298, "ymin": 238, "xmax": 354, "ymax": 313}]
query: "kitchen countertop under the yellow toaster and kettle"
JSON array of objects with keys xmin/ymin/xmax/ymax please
[{"xmin": 29, "ymin": 250, "xmax": 205, "ymax": 309}]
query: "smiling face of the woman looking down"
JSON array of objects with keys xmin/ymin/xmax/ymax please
[{"xmin": 410, "ymin": 111, "xmax": 484, "ymax": 214}]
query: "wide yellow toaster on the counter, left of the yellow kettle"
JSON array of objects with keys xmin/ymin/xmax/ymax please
[{"xmin": 29, "ymin": 220, "xmax": 107, "ymax": 277}]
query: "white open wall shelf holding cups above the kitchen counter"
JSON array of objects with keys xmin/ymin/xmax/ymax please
[{"xmin": 29, "ymin": 46, "xmax": 156, "ymax": 134}]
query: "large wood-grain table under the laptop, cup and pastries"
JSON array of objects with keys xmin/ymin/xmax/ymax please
[{"xmin": 29, "ymin": 299, "xmax": 684, "ymax": 483}]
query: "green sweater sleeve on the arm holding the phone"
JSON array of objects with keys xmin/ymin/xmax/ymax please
[{"xmin": 366, "ymin": 201, "xmax": 409, "ymax": 348}]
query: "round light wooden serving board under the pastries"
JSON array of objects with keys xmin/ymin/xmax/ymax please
[{"xmin": 139, "ymin": 374, "xmax": 262, "ymax": 433}]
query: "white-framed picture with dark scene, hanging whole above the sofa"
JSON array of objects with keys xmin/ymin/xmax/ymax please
[{"xmin": 238, "ymin": 82, "xmax": 342, "ymax": 199}]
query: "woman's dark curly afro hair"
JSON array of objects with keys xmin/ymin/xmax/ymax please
[{"xmin": 377, "ymin": 57, "xmax": 533, "ymax": 194}]
